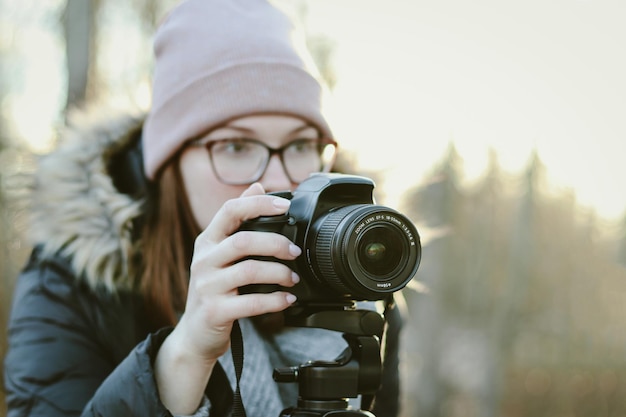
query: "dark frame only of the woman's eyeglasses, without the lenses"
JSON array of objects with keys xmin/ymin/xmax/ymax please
[{"xmin": 189, "ymin": 137, "xmax": 337, "ymax": 185}]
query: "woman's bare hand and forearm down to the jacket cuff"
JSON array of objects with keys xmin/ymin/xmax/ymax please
[{"xmin": 155, "ymin": 184, "xmax": 301, "ymax": 414}]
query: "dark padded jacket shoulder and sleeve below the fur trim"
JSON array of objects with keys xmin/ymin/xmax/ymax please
[{"xmin": 5, "ymin": 250, "xmax": 169, "ymax": 416}]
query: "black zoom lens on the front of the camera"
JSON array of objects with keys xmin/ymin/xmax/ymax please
[{"xmin": 308, "ymin": 204, "xmax": 421, "ymax": 300}]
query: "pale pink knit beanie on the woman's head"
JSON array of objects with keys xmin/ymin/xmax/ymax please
[{"xmin": 143, "ymin": 0, "xmax": 332, "ymax": 179}]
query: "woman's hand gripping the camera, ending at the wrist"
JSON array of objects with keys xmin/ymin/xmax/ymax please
[{"xmin": 177, "ymin": 184, "xmax": 301, "ymax": 360}]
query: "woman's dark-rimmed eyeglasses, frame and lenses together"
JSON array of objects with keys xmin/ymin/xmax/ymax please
[{"xmin": 191, "ymin": 138, "xmax": 337, "ymax": 185}]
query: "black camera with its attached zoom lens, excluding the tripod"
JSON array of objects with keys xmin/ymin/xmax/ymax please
[{"xmin": 239, "ymin": 173, "xmax": 421, "ymax": 305}]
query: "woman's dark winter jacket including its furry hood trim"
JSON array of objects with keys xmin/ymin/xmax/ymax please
[{"xmin": 4, "ymin": 113, "xmax": 400, "ymax": 417}]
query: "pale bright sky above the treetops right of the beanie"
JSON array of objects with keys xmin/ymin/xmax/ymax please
[{"xmin": 300, "ymin": 0, "xmax": 626, "ymax": 218}]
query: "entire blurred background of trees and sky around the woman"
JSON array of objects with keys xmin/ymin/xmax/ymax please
[{"xmin": 0, "ymin": 0, "xmax": 626, "ymax": 417}]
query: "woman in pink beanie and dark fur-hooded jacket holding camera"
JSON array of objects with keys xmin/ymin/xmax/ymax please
[{"xmin": 5, "ymin": 0, "xmax": 398, "ymax": 417}]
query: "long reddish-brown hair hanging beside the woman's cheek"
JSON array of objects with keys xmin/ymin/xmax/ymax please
[{"xmin": 140, "ymin": 153, "xmax": 201, "ymax": 328}]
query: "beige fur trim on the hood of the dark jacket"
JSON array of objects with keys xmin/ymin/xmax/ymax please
[{"xmin": 31, "ymin": 110, "xmax": 144, "ymax": 292}]
